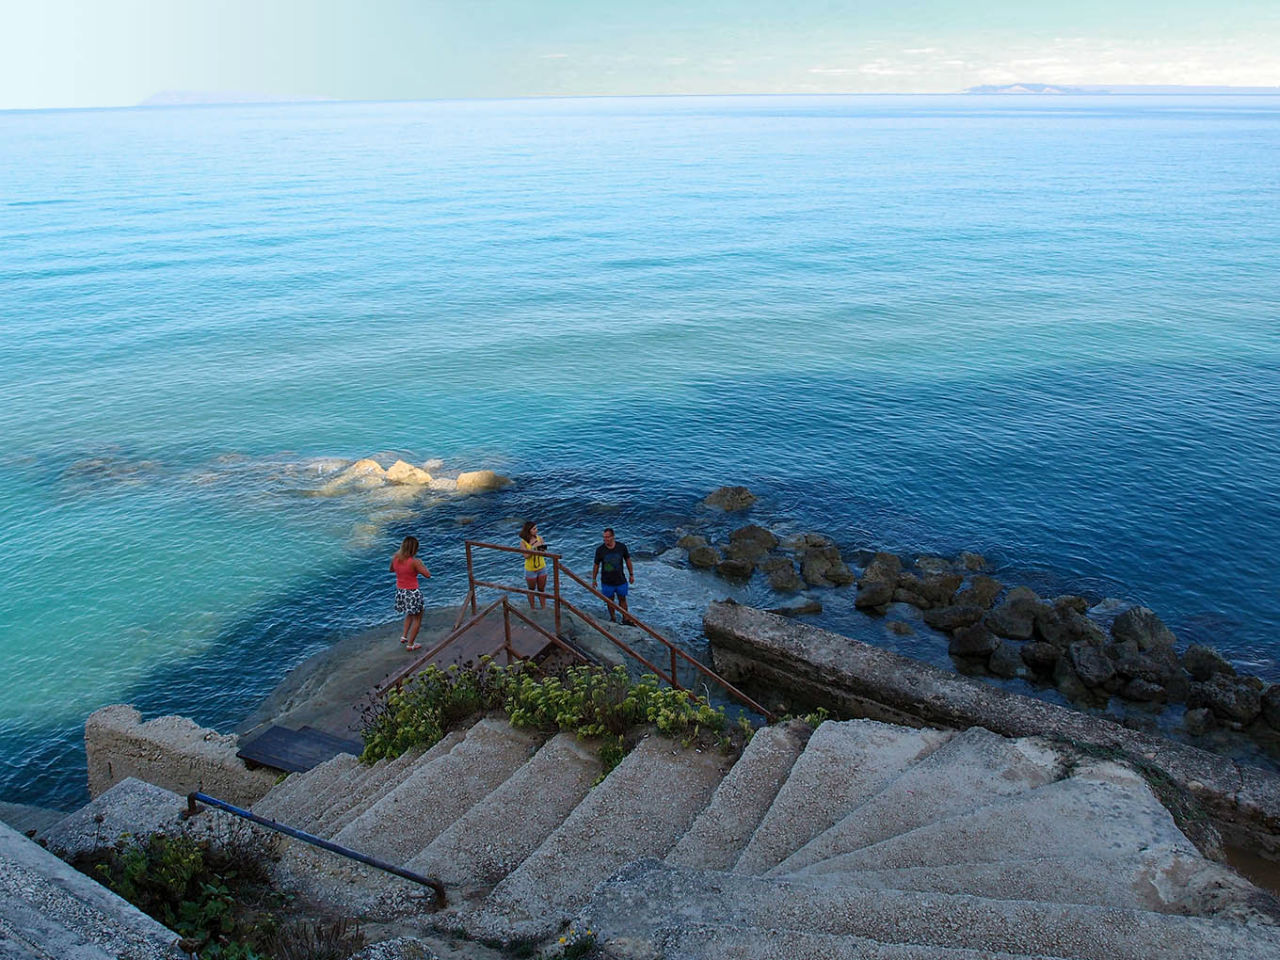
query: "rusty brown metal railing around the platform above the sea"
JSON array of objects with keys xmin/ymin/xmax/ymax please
[{"xmin": 376, "ymin": 540, "xmax": 776, "ymax": 721}]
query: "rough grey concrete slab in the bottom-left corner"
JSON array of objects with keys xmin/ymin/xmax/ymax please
[{"xmin": 0, "ymin": 824, "xmax": 184, "ymax": 960}]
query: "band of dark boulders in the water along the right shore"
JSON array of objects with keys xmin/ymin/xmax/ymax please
[{"xmin": 677, "ymin": 486, "xmax": 1280, "ymax": 748}]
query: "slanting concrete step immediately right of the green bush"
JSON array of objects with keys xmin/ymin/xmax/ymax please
[{"xmin": 667, "ymin": 722, "xmax": 810, "ymax": 870}]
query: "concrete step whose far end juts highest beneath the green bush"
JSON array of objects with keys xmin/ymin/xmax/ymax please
[{"xmin": 333, "ymin": 718, "xmax": 540, "ymax": 864}]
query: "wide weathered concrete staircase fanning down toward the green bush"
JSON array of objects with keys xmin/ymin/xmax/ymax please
[{"xmin": 52, "ymin": 717, "xmax": 1280, "ymax": 960}]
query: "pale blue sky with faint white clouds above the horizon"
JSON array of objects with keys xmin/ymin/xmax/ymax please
[{"xmin": 0, "ymin": 0, "xmax": 1280, "ymax": 109}]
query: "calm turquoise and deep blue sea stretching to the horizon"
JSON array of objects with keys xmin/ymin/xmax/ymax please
[{"xmin": 0, "ymin": 97, "xmax": 1280, "ymax": 805}]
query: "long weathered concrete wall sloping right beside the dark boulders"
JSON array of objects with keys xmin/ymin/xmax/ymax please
[{"xmin": 703, "ymin": 603, "xmax": 1280, "ymax": 858}]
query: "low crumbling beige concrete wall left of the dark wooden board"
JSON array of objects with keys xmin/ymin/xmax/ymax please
[{"xmin": 84, "ymin": 704, "xmax": 279, "ymax": 806}]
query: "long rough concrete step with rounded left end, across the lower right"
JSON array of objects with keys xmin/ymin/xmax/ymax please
[{"xmin": 573, "ymin": 860, "xmax": 1280, "ymax": 960}]
